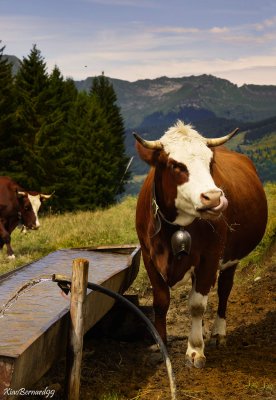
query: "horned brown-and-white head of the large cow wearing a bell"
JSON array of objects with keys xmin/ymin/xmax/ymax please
[{"xmin": 134, "ymin": 121, "xmax": 237, "ymax": 226}]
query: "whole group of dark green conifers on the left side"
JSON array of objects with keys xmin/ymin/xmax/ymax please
[{"xmin": 0, "ymin": 45, "xmax": 128, "ymax": 212}]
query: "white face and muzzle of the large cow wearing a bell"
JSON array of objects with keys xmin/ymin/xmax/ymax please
[{"xmin": 160, "ymin": 121, "xmax": 227, "ymax": 226}]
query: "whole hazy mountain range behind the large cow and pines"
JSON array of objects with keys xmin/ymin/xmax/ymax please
[{"xmin": 4, "ymin": 56, "xmax": 276, "ymax": 192}]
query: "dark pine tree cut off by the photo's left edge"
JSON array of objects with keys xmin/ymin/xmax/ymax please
[{"xmin": 0, "ymin": 41, "xmax": 20, "ymax": 175}]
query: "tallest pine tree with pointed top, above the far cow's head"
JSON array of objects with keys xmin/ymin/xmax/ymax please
[{"xmin": 16, "ymin": 45, "xmax": 49, "ymax": 190}]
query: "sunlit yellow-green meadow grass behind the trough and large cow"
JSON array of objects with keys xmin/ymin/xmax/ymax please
[{"xmin": 0, "ymin": 184, "xmax": 276, "ymax": 274}]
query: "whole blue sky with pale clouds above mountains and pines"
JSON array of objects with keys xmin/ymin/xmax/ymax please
[{"xmin": 0, "ymin": 0, "xmax": 276, "ymax": 86}]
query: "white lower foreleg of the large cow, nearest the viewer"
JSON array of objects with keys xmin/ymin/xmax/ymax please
[{"xmin": 186, "ymin": 286, "xmax": 208, "ymax": 368}]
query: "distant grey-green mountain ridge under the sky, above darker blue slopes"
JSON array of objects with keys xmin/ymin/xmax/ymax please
[{"xmin": 75, "ymin": 75, "xmax": 276, "ymax": 128}]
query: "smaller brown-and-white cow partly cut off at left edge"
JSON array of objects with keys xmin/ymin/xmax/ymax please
[{"xmin": 0, "ymin": 176, "xmax": 51, "ymax": 258}]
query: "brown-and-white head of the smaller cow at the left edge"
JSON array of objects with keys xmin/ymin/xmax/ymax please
[{"xmin": 17, "ymin": 191, "xmax": 52, "ymax": 229}]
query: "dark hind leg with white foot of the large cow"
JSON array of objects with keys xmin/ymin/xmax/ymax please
[{"xmin": 212, "ymin": 262, "xmax": 238, "ymax": 345}]
